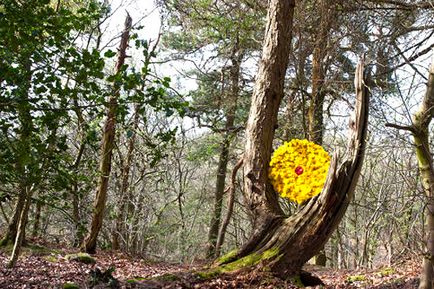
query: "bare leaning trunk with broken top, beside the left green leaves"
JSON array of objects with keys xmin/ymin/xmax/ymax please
[{"xmin": 81, "ymin": 14, "xmax": 132, "ymax": 253}]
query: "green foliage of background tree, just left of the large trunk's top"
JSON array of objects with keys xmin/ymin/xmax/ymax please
[{"xmin": 163, "ymin": 0, "xmax": 258, "ymax": 131}]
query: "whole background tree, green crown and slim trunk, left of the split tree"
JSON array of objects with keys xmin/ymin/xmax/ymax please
[{"xmin": 159, "ymin": 1, "xmax": 261, "ymax": 258}]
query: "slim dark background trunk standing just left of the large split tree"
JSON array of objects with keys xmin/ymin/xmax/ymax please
[{"xmin": 207, "ymin": 44, "xmax": 243, "ymax": 258}]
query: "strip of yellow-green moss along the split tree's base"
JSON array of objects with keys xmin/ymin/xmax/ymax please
[{"xmin": 196, "ymin": 248, "xmax": 279, "ymax": 279}]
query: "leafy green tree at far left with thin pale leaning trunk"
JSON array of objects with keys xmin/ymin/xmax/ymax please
[{"xmin": 0, "ymin": 0, "xmax": 104, "ymax": 267}]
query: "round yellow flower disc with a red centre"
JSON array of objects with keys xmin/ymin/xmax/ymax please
[{"xmin": 269, "ymin": 139, "xmax": 330, "ymax": 204}]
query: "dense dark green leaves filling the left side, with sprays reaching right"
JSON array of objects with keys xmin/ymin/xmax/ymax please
[{"xmin": 0, "ymin": 0, "xmax": 188, "ymax": 223}]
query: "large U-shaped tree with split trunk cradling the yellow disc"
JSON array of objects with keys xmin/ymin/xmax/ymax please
[{"xmin": 214, "ymin": 0, "xmax": 369, "ymax": 277}]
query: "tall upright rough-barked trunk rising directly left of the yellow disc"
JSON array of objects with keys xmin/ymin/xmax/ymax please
[{"xmin": 244, "ymin": 0, "xmax": 295, "ymax": 230}]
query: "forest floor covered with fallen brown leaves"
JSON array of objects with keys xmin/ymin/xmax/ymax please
[{"xmin": 0, "ymin": 240, "xmax": 420, "ymax": 289}]
